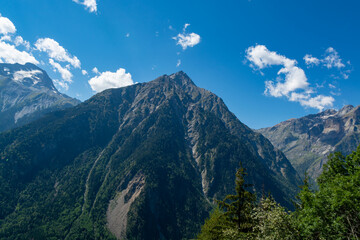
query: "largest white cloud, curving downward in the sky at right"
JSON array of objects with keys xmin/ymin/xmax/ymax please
[{"xmin": 246, "ymin": 45, "xmax": 334, "ymax": 111}]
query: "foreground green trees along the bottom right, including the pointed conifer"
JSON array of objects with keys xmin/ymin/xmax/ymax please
[{"xmin": 197, "ymin": 146, "xmax": 360, "ymax": 240}]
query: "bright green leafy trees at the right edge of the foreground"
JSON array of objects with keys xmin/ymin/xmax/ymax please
[{"xmin": 295, "ymin": 147, "xmax": 360, "ymax": 239}]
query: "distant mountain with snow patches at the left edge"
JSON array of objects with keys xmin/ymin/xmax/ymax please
[{"xmin": 0, "ymin": 63, "xmax": 79, "ymax": 132}]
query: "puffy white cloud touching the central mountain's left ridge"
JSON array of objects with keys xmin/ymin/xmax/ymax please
[{"xmin": 89, "ymin": 68, "xmax": 134, "ymax": 92}]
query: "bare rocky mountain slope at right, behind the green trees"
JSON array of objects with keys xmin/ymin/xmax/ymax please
[{"xmin": 258, "ymin": 105, "xmax": 360, "ymax": 178}]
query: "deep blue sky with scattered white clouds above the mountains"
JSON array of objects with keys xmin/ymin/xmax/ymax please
[{"xmin": 0, "ymin": 0, "xmax": 360, "ymax": 128}]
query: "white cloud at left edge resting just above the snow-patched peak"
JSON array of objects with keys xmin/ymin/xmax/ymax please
[{"xmin": 0, "ymin": 41, "xmax": 39, "ymax": 64}]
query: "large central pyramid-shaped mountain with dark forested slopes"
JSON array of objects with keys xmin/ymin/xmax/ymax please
[{"xmin": 0, "ymin": 72, "xmax": 300, "ymax": 239}]
